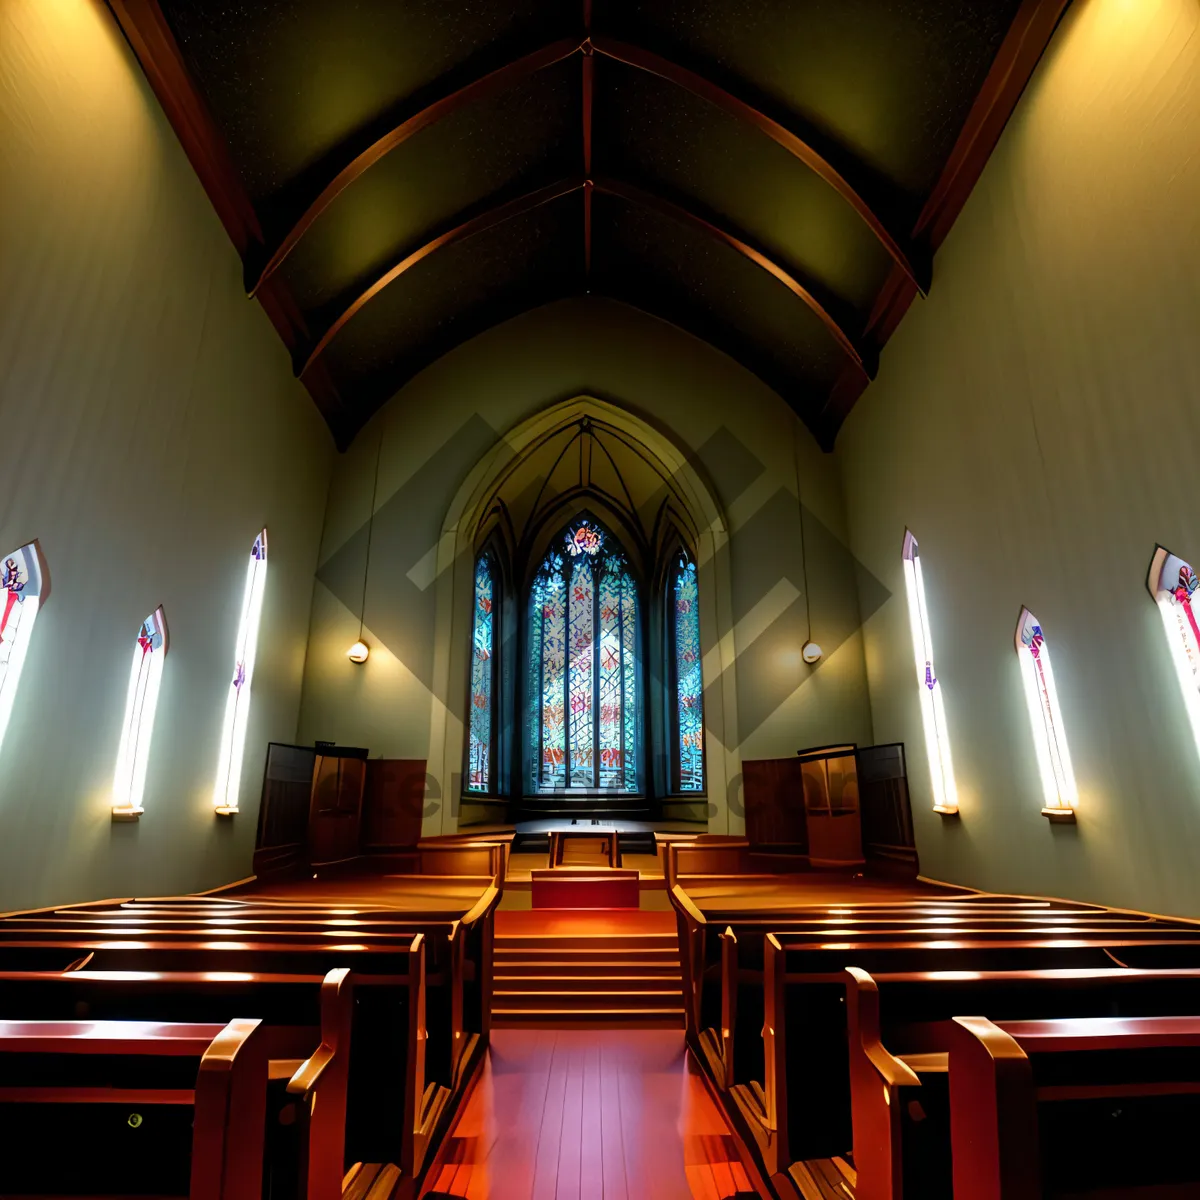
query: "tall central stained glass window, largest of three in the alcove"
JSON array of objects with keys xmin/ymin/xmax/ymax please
[{"xmin": 528, "ymin": 516, "xmax": 641, "ymax": 792}]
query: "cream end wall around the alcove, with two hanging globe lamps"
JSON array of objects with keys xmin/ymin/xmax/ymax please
[{"xmin": 300, "ymin": 298, "xmax": 870, "ymax": 827}]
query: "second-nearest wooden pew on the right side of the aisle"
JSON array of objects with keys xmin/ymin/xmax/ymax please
[{"xmin": 846, "ymin": 967, "xmax": 1200, "ymax": 1200}]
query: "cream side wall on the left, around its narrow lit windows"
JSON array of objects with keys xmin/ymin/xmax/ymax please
[{"xmin": 0, "ymin": 0, "xmax": 332, "ymax": 908}]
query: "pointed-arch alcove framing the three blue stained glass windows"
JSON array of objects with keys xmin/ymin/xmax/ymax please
[{"xmin": 426, "ymin": 396, "xmax": 740, "ymax": 834}]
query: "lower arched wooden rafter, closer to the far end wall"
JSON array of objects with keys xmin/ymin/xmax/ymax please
[{"xmin": 296, "ymin": 178, "xmax": 877, "ymax": 379}]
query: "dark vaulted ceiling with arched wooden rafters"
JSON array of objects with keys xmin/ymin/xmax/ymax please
[{"xmin": 109, "ymin": 0, "xmax": 1068, "ymax": 446}]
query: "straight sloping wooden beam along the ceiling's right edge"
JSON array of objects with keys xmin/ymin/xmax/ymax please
[{"xmin": 817, "ymin": 0, "xmax": 1070, "ymax": 450}]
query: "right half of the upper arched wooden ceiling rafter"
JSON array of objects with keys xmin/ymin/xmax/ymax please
[{"xmin": 589, "ymin": 37, "xmax": 931, "ymax": 292}]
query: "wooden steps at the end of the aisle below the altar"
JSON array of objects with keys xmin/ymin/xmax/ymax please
[{"xmin": 492, "ymin": 931, "xmax": 683, "ymax": 1028}]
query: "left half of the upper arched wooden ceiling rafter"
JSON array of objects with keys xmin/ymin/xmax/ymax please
[{"xmin": 246, "ymin": 38, "xmax": 580, "ymax": 295}]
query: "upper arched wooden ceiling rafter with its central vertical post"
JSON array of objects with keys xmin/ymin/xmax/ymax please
[{"xmin": 246, "ymin": 36, "xmax": 931, "ymax": 296}]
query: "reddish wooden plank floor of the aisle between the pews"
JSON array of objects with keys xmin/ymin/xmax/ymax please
[{"xmin": 421, "ymin": 1030, "xmax": 756, "ymax": 1200}]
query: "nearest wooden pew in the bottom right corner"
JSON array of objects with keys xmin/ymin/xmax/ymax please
[{"xmin": 949, "ymin": 1016, "xmax": 1200, "ymax": 1200}]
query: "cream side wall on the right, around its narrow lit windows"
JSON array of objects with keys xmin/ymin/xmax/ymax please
[{"xmin": 836, "ymin": 0, "xmax": 1200, "ymax": 914}]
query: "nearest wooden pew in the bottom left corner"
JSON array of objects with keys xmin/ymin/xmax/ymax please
[{"xmin": 0, "ymin": 1020, "xmax": 266, "ymax": 1200}]
